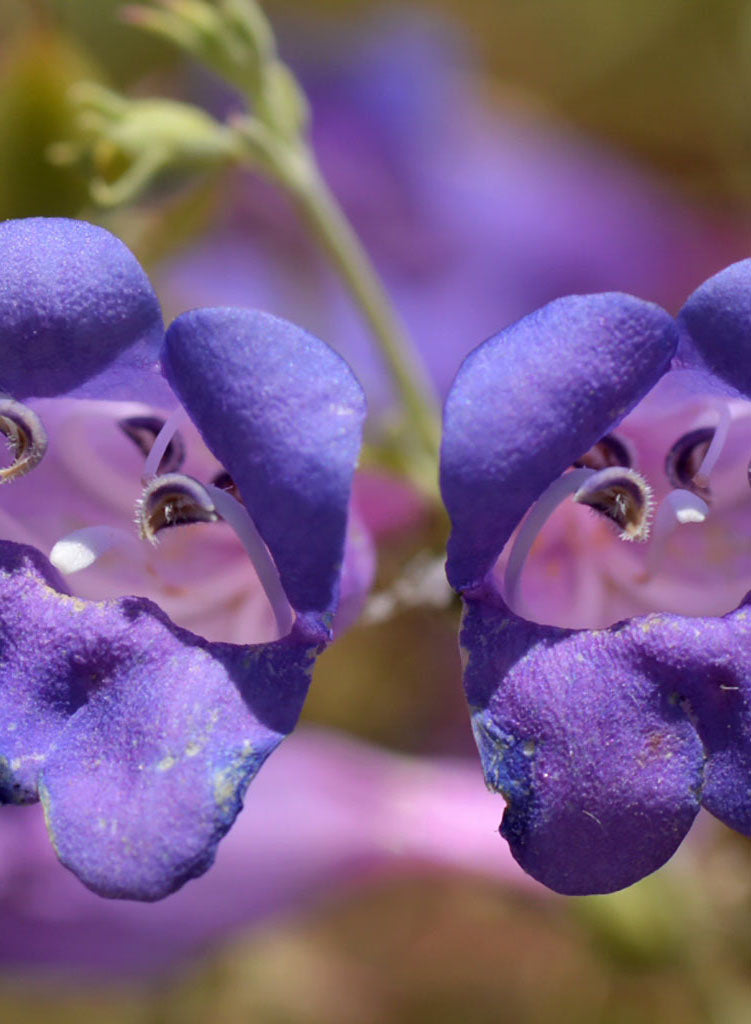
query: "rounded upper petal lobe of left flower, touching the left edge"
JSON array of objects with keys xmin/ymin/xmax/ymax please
[{"xmin": 0, "ymin": 217, "xmax": 174, "ymax": 406}]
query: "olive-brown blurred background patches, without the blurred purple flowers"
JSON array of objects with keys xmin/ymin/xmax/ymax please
[{"xmin": 0, "ymin": 0, "xmax": 751, "ymax": 1024}]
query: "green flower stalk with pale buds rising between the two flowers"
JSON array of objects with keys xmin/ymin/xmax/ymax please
[{"xmin": 67, "ymin": 0, "xmax": 441, "ymax": 491}]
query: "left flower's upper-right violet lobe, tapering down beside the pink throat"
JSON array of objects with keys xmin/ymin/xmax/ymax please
[{"xmin": 162, "ymin": 309, "xmax": 365, "ymax": 614}]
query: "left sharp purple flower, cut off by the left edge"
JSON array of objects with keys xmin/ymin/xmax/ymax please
[{"xmin": 0, "ymin": 219, "xmax": 365, "ymax": 900}]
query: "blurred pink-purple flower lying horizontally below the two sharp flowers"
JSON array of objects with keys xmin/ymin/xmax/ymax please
[{"xmin": 0, "ymin": 727, "xmax": 543, "ymax": 975}]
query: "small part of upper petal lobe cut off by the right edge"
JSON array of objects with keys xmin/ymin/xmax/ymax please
[{"xmin": 676, "ymin": 259, "xmax": 751, "ymax": 397}]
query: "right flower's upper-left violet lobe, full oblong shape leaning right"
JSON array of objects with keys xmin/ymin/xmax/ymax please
[{"xmin": 441, "ymin": 292, "xmax": 678, "ymax": 591}]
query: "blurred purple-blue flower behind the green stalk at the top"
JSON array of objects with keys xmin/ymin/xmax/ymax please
[{"xmin": 160, "ymin": 20, "xmax": 745, "ymax": 411}]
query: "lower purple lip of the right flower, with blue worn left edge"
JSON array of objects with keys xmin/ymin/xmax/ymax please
[{"xmin": 461, "ymin": 590, "xmax": 751, "ymax": 894}]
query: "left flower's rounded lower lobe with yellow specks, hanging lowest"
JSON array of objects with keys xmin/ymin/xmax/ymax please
[{"xmin": 40, "ymin": 630, "xmax": 312, "ymax": 900}]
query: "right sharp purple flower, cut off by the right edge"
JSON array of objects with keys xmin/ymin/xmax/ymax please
[{"xmin": 442, "ymin": 261, "xmax": 751, "ymax": 894}]
